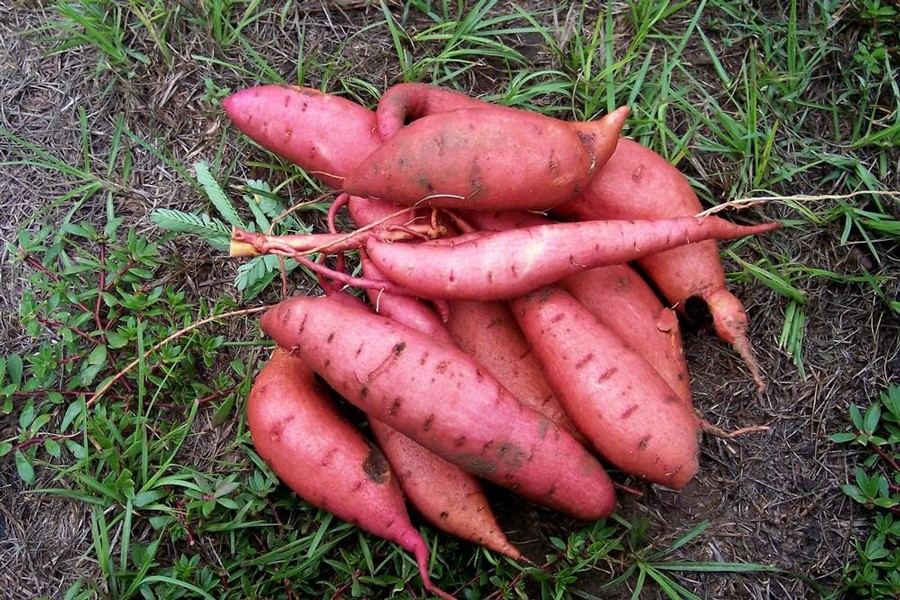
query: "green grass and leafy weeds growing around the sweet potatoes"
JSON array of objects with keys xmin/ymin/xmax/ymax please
[{"xmin": 0, "ymin": 0, "xmax": 900, "ymax": 598}]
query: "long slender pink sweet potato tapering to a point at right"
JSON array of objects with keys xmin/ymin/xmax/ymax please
[{"xmin": 366, "ymin": 217, "xmax": 780, "ymax": 300}]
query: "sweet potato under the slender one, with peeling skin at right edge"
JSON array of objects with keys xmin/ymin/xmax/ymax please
[{"xmin": 466, "ymin": 211, "xmax": 693, "ymax": 406}]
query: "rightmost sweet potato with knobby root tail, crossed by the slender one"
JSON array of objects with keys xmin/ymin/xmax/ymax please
[{"xmin": 557, "ymin": 138, "xmax": 765, "ymax": 391}]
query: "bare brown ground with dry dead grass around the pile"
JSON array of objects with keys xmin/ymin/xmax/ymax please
[{"xmin": 0, "ymin": 2, "xmax": 900, "ymax": 600}]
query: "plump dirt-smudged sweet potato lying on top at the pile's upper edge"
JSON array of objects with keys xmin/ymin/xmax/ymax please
[{"xmin": 344, "ymin": 109, "xmax": 594, "ymax": 210}]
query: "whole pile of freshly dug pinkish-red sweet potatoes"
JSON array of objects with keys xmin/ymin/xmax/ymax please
[{"xmin": 224, "ymin": 84, "xmax": 778, "ymax": 597}]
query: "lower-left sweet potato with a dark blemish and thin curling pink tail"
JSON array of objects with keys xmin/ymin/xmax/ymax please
[{"xmin": 247, "ymin": 350, "xmax": 452, "ymax": 598}]
